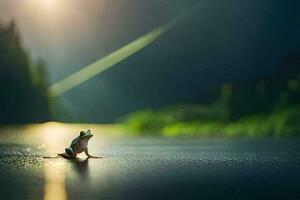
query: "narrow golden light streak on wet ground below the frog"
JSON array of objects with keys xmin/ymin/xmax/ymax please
[{"xmin": 44, "ymin": 160, "xmax": 67, "ymax": 200}]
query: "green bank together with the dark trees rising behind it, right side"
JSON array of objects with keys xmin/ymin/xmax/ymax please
[{"xmin": 123, "ymin": 54, "xmax": 300, "ymax": 137}]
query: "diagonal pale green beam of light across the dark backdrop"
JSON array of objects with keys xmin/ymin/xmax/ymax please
[{"xmin": 48, "ymin": 19, "xmax": 178, "ymax": 97}]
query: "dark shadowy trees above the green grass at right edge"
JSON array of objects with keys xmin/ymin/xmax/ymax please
[{"xmin": 227, "ymin": 50, "xmax": 300, "ymax": 120}]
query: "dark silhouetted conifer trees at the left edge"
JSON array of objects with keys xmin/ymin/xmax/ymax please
[{"xmin": 0, "ymin": 22, "xmax": 50, "ymax": 124}]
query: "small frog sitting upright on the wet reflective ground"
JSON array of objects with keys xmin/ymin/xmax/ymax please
[{"xmin": 58, "ymin": 130, "xmax": 102, "ymax": 159}]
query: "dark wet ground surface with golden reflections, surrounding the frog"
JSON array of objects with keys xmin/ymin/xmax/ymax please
[{"xmin": 0, "ymin": 123, "xmax": 300, "ymax": 200}]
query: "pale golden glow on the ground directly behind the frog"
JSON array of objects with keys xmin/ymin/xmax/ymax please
[{"xmin": 21, "ymin": 122, "xmax": 115, "ymax": 157}]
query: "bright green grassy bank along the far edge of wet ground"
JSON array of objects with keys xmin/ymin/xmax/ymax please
[{"xmin": 123, "ymin": 106, "xmax": 300, "ymax": 137}]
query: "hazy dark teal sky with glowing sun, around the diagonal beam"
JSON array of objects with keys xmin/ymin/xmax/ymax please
[{"xmin": 0, "ymin": 0, "xmax": 300, "ymax": 122}]
